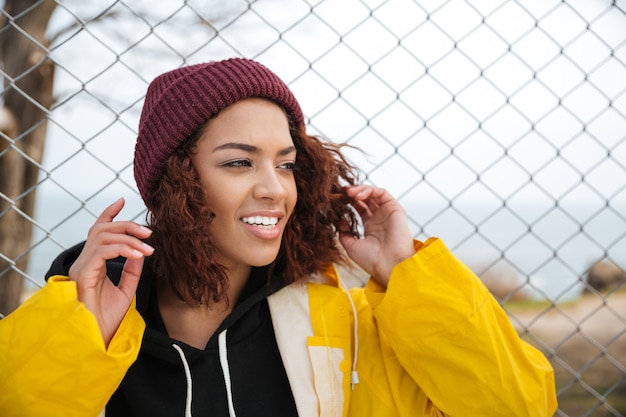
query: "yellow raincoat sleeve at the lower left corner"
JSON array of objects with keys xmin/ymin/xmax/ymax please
[{"xmin": 0, "ymin": 276, "xmax": 145, "ymax": 417}]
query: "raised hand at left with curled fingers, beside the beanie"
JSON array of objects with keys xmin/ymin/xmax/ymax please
[{"xmin": 69, "ymin": 198, "xmax": 154, "ymax": 347}]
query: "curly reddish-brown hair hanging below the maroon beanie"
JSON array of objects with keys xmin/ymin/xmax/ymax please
[{"xmin": 146, "ymin": 112, "xmax": 359, "ymax": 305}]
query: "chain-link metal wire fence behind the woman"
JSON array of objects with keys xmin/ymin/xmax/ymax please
[{"xmin": 0, "ymin": 0, "xmax": 626, "ymax": 416}]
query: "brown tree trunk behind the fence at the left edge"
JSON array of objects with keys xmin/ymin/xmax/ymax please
[{"xmin": 0, "ymin": 0, "xmax": 56, "ymax": 317}]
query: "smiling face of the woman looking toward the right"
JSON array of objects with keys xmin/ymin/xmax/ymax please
[{"xmin": 191, "ymin": 98, "xmax": 297, "ymax": 272}]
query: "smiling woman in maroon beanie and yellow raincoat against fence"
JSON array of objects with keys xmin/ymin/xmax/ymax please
[{"xmin": 0, "ymin": 59, "xmax": 556, "ymax": 417}]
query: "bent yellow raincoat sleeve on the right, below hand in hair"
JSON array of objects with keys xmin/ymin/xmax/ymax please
[{"xmin": 365, "ymin": 239, "xmax": 557, "ymax": 417}]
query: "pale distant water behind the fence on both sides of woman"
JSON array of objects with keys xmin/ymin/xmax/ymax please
[{"xmin": 23, "ymin": 193, "xmax": 626, "ymax": 301}]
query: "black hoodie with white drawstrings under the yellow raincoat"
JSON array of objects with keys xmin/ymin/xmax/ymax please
[{"xmin": 46, "ymin": 243, "xmax": 297, "ymax": 417}]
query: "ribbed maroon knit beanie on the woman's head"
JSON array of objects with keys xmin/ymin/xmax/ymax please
[{"xmin": 134, "ymin": 58, "xmax": 304, "ymax": 203}]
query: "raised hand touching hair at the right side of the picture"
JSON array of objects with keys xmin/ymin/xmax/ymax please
[{"xmin": 339, "ymin": 184, "xmax": 415, "ymax": 287}]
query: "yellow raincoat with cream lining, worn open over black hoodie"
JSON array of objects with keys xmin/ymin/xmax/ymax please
[{"xmin": 0, "ymin": 239, "xmax": 557, "ymax": 417}]
